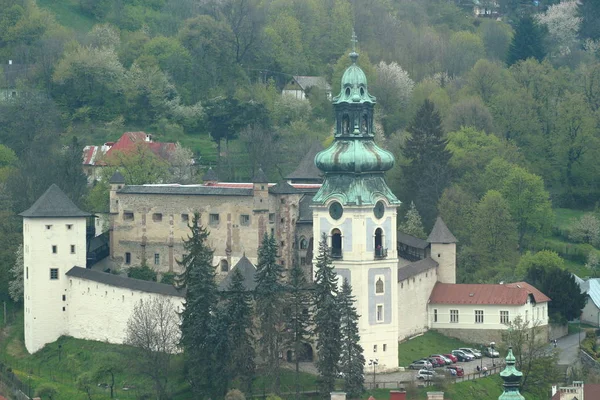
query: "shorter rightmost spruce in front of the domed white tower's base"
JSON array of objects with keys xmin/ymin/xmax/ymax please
[{"xmin": 338, "ymin": 279, "xmax": 365, "ymax": 398}]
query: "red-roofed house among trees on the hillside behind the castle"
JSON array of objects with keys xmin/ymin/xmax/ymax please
[{"xmin": 83, "ymin": 132, "xmax": 177, "ymax": 183}]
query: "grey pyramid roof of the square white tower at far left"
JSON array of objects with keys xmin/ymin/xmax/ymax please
[{"xmin": 19, "ymin": 183, "xmax": 92, "ymax": 218}]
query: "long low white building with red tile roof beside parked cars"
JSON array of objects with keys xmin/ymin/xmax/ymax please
[{"xmin": 428, "ymin": 282, "xmax": 550, "ymax": 343}]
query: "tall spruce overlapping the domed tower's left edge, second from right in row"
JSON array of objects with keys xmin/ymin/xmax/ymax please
[{"xmin": 314, "ymin": 233, "xmax": 340, "ymax": 394}]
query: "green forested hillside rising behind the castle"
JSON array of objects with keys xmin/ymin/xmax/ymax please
[{"xmin": 0, "ymin": 0, "xmax": 600, "ymax": 297}]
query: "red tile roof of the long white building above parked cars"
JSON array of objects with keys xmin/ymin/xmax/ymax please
[{"xmin": 429, "ymin": 282, "xmax": 550, "ymax": 305}]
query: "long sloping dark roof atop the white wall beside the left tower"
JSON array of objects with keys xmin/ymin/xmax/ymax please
[{"xmin": 66, "ymin": 267, "xmax": 185, "ymax": 297}]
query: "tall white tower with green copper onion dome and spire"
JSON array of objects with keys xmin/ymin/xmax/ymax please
[{"xmin": 312, "ymin": 33, "xmax": 400, "ymax": 369}]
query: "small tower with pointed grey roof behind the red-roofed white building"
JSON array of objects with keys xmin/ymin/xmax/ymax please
[{"xmin": 427, "ymin": 217, "xmax": 458, "ymax": 283}]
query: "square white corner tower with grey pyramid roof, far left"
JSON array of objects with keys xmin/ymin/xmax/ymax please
[{"xmin": 20, "ymin": 185, "xmax": 90, "ymax": 353}]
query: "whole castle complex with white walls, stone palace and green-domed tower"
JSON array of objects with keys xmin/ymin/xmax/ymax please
[{"xmin": 21, "ymin": 45, "xmax": 550, "ymax": 370}]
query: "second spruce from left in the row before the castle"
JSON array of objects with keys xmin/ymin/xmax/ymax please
[{"xmin": 225, "ymin": 268, "xmax": 256, "ymax": 393}]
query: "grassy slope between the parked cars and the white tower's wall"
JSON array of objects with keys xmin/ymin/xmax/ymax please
[{"xmin": 398, "ymin": 331, "xmax": 471, "ymax": 367}]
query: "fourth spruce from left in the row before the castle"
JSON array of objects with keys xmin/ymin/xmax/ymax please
[{"xmin": 286, "ymin": 263, "xmax": 312, "ymax": 393}]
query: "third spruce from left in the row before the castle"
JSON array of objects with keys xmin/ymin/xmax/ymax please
[{"xmin": 255, "ymin": 234, "xmax": 284, "ymax": 393}]
